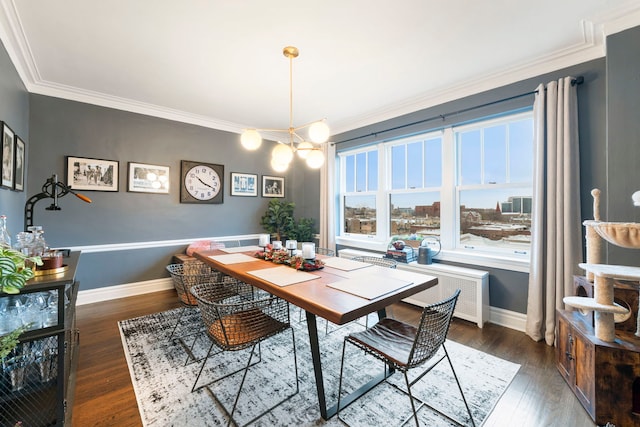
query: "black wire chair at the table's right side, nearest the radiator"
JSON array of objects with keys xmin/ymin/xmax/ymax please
[{"xmin": 337, "ymin": 289, "xmax": 475, "ymax": 427}]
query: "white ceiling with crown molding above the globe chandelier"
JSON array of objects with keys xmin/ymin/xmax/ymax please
[{"xmin": 0, "ymin": 0, "xmax": 640, "ymax": 134}]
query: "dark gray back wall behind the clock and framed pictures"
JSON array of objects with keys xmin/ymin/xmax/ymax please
[{"xmin": 29, "ymin": 94, "xmax": 318, "ymax": 290}]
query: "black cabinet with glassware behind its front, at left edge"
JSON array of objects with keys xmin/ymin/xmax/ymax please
[{"xmin": 0, "ymin": 252, "xmax": 80, "ymax": 427}]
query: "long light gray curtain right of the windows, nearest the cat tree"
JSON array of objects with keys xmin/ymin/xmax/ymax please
[{"xmin": 526, "ymin": 77, "xmax": 582, "ymax": 345}]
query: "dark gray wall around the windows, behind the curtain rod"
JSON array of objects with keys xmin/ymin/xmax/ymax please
[{"xmin": 334, "ymin": 58, "xmax": 606, "ymax": 313}]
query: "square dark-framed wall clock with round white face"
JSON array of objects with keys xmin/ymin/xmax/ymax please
[{"xmin": 180, "ymin": 160, "xmax": 224, "ymax": 203}]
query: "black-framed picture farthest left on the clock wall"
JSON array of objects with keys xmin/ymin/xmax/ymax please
[{"xmin": 67, "ymin": 156, "xmax": 119, "ymax": 191}]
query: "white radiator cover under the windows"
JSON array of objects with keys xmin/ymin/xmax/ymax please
[{"xmin": 338, "ymin": 249, "xmax": 489, "ymax": 328}]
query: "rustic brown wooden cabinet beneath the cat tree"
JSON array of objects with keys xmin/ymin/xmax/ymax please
[{"xmin": 556, "ymin": 310, "xmax": 640, "ymax": 426}]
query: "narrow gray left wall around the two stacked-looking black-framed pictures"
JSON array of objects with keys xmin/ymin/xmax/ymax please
[{"xmin": 0, "ymin": 39, "xmax": 29, "ymax": 234}]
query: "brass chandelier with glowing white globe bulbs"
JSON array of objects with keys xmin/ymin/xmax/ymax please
[{"xmin": 240, "ymin": 46, "xmax": 330, "ymax": 172}]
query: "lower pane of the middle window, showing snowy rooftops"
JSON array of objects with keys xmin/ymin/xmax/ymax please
[{"xmin": 389, "ymin": 191, "xmax": 440, "ymax": 238}]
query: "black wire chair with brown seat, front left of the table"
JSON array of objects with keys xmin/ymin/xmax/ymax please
[{"xmin": 191, "ymin": 285, "xmax": 300, "ymax": 425}]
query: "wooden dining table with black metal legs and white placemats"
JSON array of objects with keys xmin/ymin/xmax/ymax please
[{"xmin": 194, "ymin": 246, "xmax": 438, "ymax": 420}]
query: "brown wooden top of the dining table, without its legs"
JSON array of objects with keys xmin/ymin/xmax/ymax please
[{"xmin": 194, "ymin": 250, "xmax": 438, "ymax": 325}]
